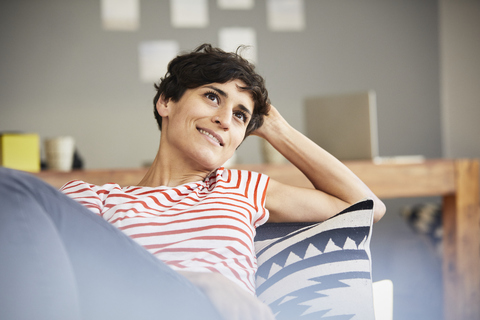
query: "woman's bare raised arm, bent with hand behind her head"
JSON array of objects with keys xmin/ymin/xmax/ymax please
[{"xmin": 253, "ymin": 106, "xmax": 385, "ymax": 222}]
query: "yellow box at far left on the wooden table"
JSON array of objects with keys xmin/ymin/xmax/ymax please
[{"xmin": 0, "ymin": 133, "xmax": 40, "ymax": 172}]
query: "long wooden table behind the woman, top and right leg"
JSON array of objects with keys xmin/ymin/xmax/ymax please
[{"xmin": 31, "ymin": 159, "xmax": 480, "ymax": 320}]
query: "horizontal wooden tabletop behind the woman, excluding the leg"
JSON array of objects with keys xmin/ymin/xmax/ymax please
[{"xmin": 36, "ymin": 160, "xmax": 455, "ymax": 199}]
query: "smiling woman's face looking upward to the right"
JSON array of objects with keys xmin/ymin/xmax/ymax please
[{"xmin": 157, "ymin": 80, "xmax": 254, "ymax": 171}]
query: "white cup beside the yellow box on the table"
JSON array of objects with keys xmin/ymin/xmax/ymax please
[{"xmin": 45, "ymin": 136, "xmax": 75, "ymax": 171}]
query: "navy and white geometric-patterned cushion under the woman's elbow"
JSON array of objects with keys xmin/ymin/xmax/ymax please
[{"xmin": 255, "ymin": 199, "xmax": 374, "ymax": 320}]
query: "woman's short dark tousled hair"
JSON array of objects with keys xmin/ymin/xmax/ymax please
[{"xmin": 153, "ymin": 44, "xmax": 270, "ymax": 136}]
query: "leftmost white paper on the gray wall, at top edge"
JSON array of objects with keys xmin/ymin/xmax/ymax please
[{"xmin": 101, "ymin": 0, "xmax": 140, "ymax": 31}]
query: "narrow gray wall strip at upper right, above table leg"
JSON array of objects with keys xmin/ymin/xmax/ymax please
[{"xmin": 440, "ymin": 0, "xmax": 480, "ymax": 158}]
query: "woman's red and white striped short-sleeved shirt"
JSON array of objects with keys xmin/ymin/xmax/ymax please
[{"xmin": 61, "ymin": 168, "xmax": 269, "ymax": 293}]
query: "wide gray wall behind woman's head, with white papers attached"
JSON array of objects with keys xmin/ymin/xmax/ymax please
[{"xmin": 0, "ymin": 0, "xmax": 442, "ymax": 168}]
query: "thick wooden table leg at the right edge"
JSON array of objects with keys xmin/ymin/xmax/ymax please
[{"xmin": 442, "ymin": 160, "xmax": 480, "ymax": 320}]
